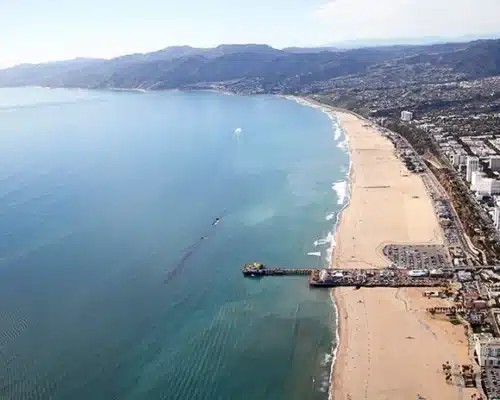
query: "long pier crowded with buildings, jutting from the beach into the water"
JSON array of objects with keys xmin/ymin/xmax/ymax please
[{"xmin": 242, "ymin": 263, "xmax": 453, "ymax": 288}]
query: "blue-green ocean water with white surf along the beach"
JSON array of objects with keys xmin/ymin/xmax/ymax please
[{"xmin": 0, "ymin": 88, "xmax": 349, "ymax": 400}]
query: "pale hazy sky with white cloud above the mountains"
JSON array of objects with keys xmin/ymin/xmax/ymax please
[{"xmin": 0, "ymin": 0, "xmax": 500, "ymax": 67}]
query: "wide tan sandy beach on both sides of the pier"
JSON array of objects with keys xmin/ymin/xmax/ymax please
[{"xmin": 332, "ymin": 112, "xmax": 474, "ymax": 400}]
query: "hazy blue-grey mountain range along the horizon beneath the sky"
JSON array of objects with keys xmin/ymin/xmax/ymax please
[{"xmin": 0, "ymin": 40, "xmax": 500, "ymax": 93}]
